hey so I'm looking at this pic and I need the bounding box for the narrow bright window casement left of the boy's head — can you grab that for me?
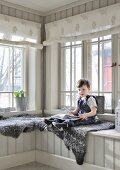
[60,41,82,107]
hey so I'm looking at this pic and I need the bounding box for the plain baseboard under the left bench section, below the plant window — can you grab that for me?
[0,150,35,170]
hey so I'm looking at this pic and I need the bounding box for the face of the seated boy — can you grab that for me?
[78,85,90,97]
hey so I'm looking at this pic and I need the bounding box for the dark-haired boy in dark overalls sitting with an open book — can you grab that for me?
[45,79,97,128]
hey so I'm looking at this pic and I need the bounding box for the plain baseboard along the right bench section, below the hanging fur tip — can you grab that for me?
[36,150,113,170]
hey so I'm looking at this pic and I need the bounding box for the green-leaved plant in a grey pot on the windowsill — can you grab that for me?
[13,90,27,111]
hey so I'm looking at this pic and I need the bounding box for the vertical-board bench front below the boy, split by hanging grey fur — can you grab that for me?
[36,131,120,170]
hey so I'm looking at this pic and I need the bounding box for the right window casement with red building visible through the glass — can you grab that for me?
[88,35,112,110]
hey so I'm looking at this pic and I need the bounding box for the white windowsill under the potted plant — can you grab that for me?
[0,110,42,117]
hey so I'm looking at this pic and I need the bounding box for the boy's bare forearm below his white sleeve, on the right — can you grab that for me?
[80,107,97,119]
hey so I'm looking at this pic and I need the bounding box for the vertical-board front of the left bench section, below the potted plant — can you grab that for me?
[0,131,35,157]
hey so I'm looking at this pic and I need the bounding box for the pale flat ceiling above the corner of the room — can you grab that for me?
[4,0,83,13]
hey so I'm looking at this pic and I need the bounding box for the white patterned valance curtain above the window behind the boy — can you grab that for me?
[43,4,120,45]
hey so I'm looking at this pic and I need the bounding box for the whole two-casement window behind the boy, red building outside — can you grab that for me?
[60,35,112,110]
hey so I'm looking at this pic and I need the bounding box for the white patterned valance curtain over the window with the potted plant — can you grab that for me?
[0,14,43,49]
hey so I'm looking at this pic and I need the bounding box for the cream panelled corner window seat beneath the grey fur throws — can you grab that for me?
[0,114,120,170]
